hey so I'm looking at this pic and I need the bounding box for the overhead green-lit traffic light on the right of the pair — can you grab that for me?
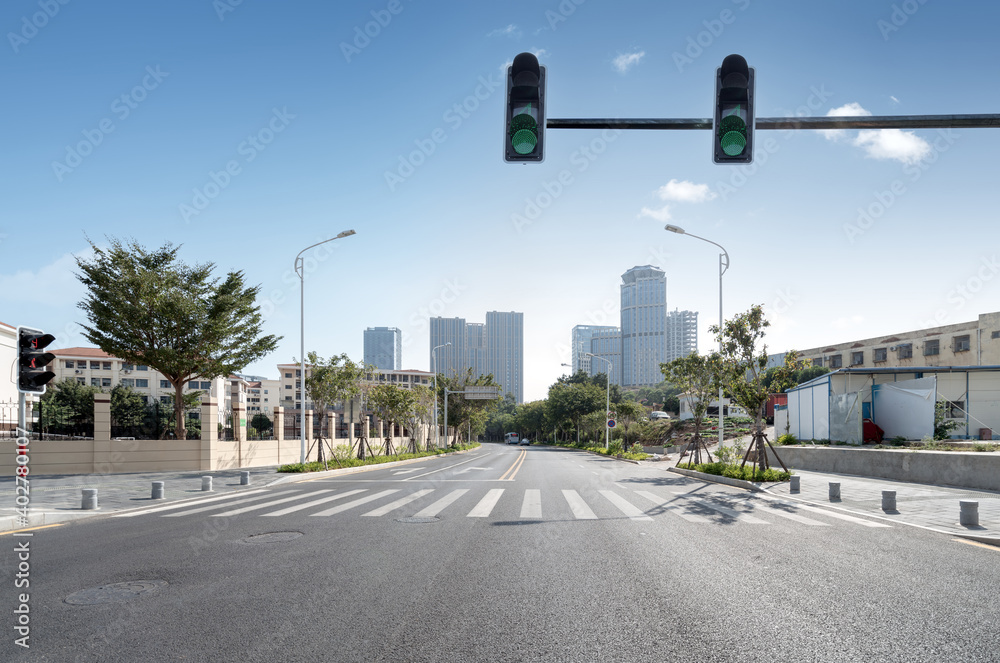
[712,54,754,163]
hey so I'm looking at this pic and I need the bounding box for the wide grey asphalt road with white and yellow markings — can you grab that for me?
[0,445,1000,663]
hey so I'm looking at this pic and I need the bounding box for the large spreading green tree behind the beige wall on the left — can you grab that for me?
[76,239,279,439]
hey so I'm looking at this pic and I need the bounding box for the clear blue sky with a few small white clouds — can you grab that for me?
[0,0,1000,400]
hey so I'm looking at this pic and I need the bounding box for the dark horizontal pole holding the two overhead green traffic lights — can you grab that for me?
[545,113,1000,131]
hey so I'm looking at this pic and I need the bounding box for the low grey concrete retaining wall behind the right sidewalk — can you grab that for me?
[768,446,1000,491]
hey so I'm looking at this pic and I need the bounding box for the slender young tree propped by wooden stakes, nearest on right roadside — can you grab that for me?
[709,304,802,471]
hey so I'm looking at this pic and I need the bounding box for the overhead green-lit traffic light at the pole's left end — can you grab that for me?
[503,53,545,163]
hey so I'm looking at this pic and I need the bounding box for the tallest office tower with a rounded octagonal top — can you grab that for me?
[621,265,667,387]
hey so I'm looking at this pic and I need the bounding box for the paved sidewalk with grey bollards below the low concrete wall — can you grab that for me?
[764,470,1000,545]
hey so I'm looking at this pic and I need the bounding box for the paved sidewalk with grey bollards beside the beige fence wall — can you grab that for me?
[0,466,286,532]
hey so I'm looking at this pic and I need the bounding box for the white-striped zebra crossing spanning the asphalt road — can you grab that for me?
[112,484,891,527]
